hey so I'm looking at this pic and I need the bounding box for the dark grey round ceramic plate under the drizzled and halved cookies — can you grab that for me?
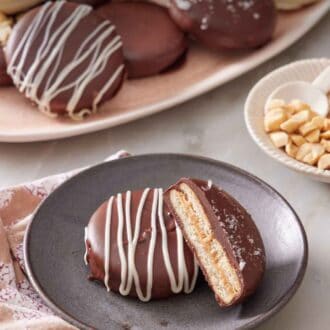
[25,154,307,329]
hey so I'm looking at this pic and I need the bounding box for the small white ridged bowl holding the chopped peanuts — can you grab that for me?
[244,58,330,183]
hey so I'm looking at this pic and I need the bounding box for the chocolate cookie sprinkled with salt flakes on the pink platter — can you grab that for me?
[169,0,276,50]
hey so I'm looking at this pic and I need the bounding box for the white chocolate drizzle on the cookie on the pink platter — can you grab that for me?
[7,1,124,119]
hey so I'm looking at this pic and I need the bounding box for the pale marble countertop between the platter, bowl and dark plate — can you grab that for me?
[0,13,330,330]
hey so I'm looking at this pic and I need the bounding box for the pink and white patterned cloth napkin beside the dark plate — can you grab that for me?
[0,151,129,330]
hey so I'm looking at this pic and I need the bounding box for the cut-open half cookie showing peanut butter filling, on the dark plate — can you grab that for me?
[164,178,265,307]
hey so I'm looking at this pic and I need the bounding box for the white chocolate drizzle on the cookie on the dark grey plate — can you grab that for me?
[85,188,198,302]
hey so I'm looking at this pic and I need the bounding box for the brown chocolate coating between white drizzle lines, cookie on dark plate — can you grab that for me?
[85,190,197,299]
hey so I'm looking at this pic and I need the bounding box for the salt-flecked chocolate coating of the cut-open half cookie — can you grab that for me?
[164,178,266,307]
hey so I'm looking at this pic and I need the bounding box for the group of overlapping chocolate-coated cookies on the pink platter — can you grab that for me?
[0,0,276,119]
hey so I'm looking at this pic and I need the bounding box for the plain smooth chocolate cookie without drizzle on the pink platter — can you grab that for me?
[97,2,187,78]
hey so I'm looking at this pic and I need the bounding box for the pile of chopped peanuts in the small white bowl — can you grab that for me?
[264,100,330,170]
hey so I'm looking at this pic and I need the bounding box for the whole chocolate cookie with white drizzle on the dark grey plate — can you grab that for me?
[85,189,198,302]
